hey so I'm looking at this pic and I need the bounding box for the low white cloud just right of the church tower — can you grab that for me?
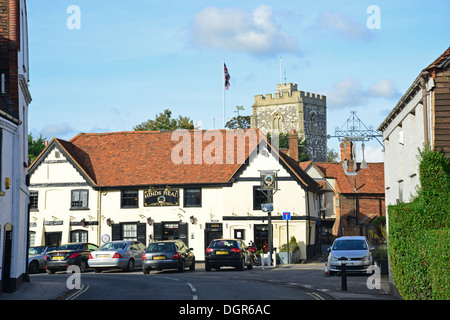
[326,77,399,107]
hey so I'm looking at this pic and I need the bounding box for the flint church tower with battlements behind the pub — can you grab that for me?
[251,83,327,162]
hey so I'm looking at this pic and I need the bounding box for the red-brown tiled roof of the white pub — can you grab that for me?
[30,129,317,189]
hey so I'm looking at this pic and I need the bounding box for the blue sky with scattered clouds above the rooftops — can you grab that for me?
[27,0,450,162]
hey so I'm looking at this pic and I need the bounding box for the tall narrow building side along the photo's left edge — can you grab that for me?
[0,0,31,293]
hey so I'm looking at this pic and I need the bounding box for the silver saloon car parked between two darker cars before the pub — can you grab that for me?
[88,241,145,272]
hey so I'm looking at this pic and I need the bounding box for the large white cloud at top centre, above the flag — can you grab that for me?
[192,5,298,55]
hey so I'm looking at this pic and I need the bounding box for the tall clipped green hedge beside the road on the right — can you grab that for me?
[388,147,450,300]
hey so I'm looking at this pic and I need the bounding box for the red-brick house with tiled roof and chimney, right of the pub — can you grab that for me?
[300,141,386,244]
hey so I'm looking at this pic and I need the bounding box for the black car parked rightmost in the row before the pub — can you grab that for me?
[205,239,253,271]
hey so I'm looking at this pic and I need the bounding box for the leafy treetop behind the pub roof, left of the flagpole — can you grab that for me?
[133,109,194,131]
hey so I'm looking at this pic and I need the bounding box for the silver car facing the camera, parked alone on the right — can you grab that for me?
[328,236,374,275]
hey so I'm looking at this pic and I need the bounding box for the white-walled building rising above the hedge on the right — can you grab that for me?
[378,48,450,205]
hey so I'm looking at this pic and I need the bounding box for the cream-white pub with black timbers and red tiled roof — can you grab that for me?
[29,129,322,261]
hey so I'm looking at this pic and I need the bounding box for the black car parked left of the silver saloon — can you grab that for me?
[44,242,98,274]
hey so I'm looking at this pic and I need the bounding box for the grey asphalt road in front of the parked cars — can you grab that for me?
[31,263,321,301]
